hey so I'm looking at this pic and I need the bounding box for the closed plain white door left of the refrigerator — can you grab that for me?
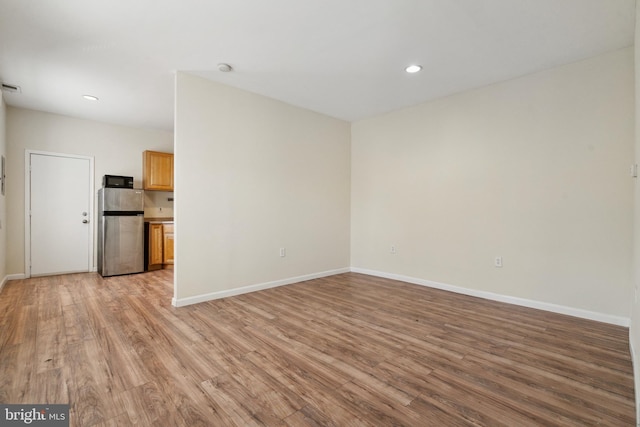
[27,152,93,276]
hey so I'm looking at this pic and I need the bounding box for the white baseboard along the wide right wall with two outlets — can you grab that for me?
[351,267,631,327]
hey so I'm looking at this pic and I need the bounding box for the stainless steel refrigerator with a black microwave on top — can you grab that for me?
[98,188,144,277]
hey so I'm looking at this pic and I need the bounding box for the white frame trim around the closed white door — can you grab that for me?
[24,149,96,279]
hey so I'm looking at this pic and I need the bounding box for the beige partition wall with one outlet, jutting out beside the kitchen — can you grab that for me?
[175,73,350,303]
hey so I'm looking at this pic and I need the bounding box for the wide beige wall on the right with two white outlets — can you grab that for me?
[351,48,634,318]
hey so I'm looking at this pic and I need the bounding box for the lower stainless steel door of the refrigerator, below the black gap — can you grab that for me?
[99,214,144,276]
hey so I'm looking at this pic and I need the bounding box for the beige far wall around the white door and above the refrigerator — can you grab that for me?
[7,107,173,275]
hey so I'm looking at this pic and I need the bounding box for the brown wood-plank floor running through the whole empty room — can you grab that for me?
[0,270,635,427]
